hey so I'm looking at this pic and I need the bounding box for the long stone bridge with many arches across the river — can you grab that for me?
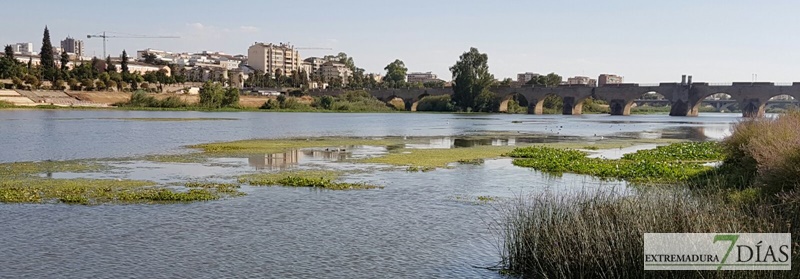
[310,81,800,117]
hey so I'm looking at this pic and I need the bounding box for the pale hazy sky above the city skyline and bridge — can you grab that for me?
[0,0,800,83]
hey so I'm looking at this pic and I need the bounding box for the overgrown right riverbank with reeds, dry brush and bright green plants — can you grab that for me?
[496,112,800,278]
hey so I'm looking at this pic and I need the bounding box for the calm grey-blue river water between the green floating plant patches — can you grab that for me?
[0,110,739,278]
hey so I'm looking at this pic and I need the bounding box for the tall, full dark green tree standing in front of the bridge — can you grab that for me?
[450,47,494,111]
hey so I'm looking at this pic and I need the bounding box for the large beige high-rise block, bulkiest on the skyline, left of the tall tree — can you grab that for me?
[247,43,301,75]
